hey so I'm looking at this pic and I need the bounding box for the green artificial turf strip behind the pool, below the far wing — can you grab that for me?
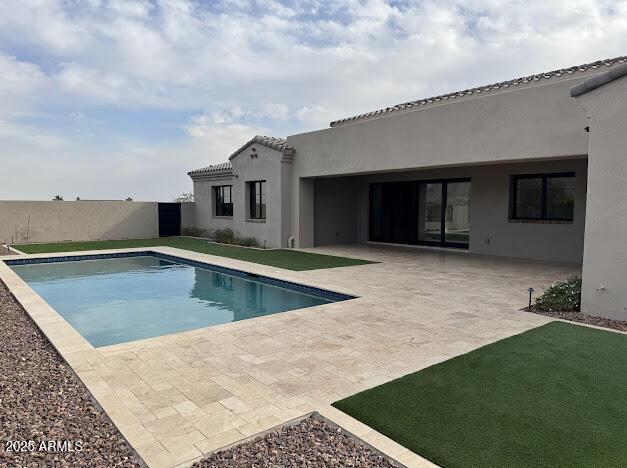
[14,236,374,271]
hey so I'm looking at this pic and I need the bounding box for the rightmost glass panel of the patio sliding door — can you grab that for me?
[444,181,470,245]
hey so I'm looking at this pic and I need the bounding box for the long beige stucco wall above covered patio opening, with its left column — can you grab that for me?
[287,72,598,245]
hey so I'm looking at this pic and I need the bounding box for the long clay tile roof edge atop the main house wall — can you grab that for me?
[331,56,627,127]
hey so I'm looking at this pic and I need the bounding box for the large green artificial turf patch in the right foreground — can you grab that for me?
[334,322,627,467]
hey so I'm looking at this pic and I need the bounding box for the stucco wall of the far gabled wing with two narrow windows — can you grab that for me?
[194,143,291,247]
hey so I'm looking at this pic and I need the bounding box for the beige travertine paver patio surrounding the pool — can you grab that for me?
[0,245,579,466]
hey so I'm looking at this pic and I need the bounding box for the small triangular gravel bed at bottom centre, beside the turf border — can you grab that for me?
[192,416,400,468]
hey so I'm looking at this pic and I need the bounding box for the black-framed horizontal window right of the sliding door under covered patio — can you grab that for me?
[510,172,575,221]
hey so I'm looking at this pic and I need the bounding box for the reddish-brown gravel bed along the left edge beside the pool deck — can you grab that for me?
[0,282,143,467]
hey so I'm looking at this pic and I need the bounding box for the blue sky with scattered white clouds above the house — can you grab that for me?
[0,0,627,201]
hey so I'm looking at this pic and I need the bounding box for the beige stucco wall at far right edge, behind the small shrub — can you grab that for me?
[577,77,627,320]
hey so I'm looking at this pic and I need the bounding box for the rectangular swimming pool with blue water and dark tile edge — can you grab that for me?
[5,252,353,347]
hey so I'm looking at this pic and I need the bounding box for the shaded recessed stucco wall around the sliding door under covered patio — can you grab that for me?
[315,158,587,263]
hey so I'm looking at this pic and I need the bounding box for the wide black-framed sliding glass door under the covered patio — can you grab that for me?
[370,179,470,248]
